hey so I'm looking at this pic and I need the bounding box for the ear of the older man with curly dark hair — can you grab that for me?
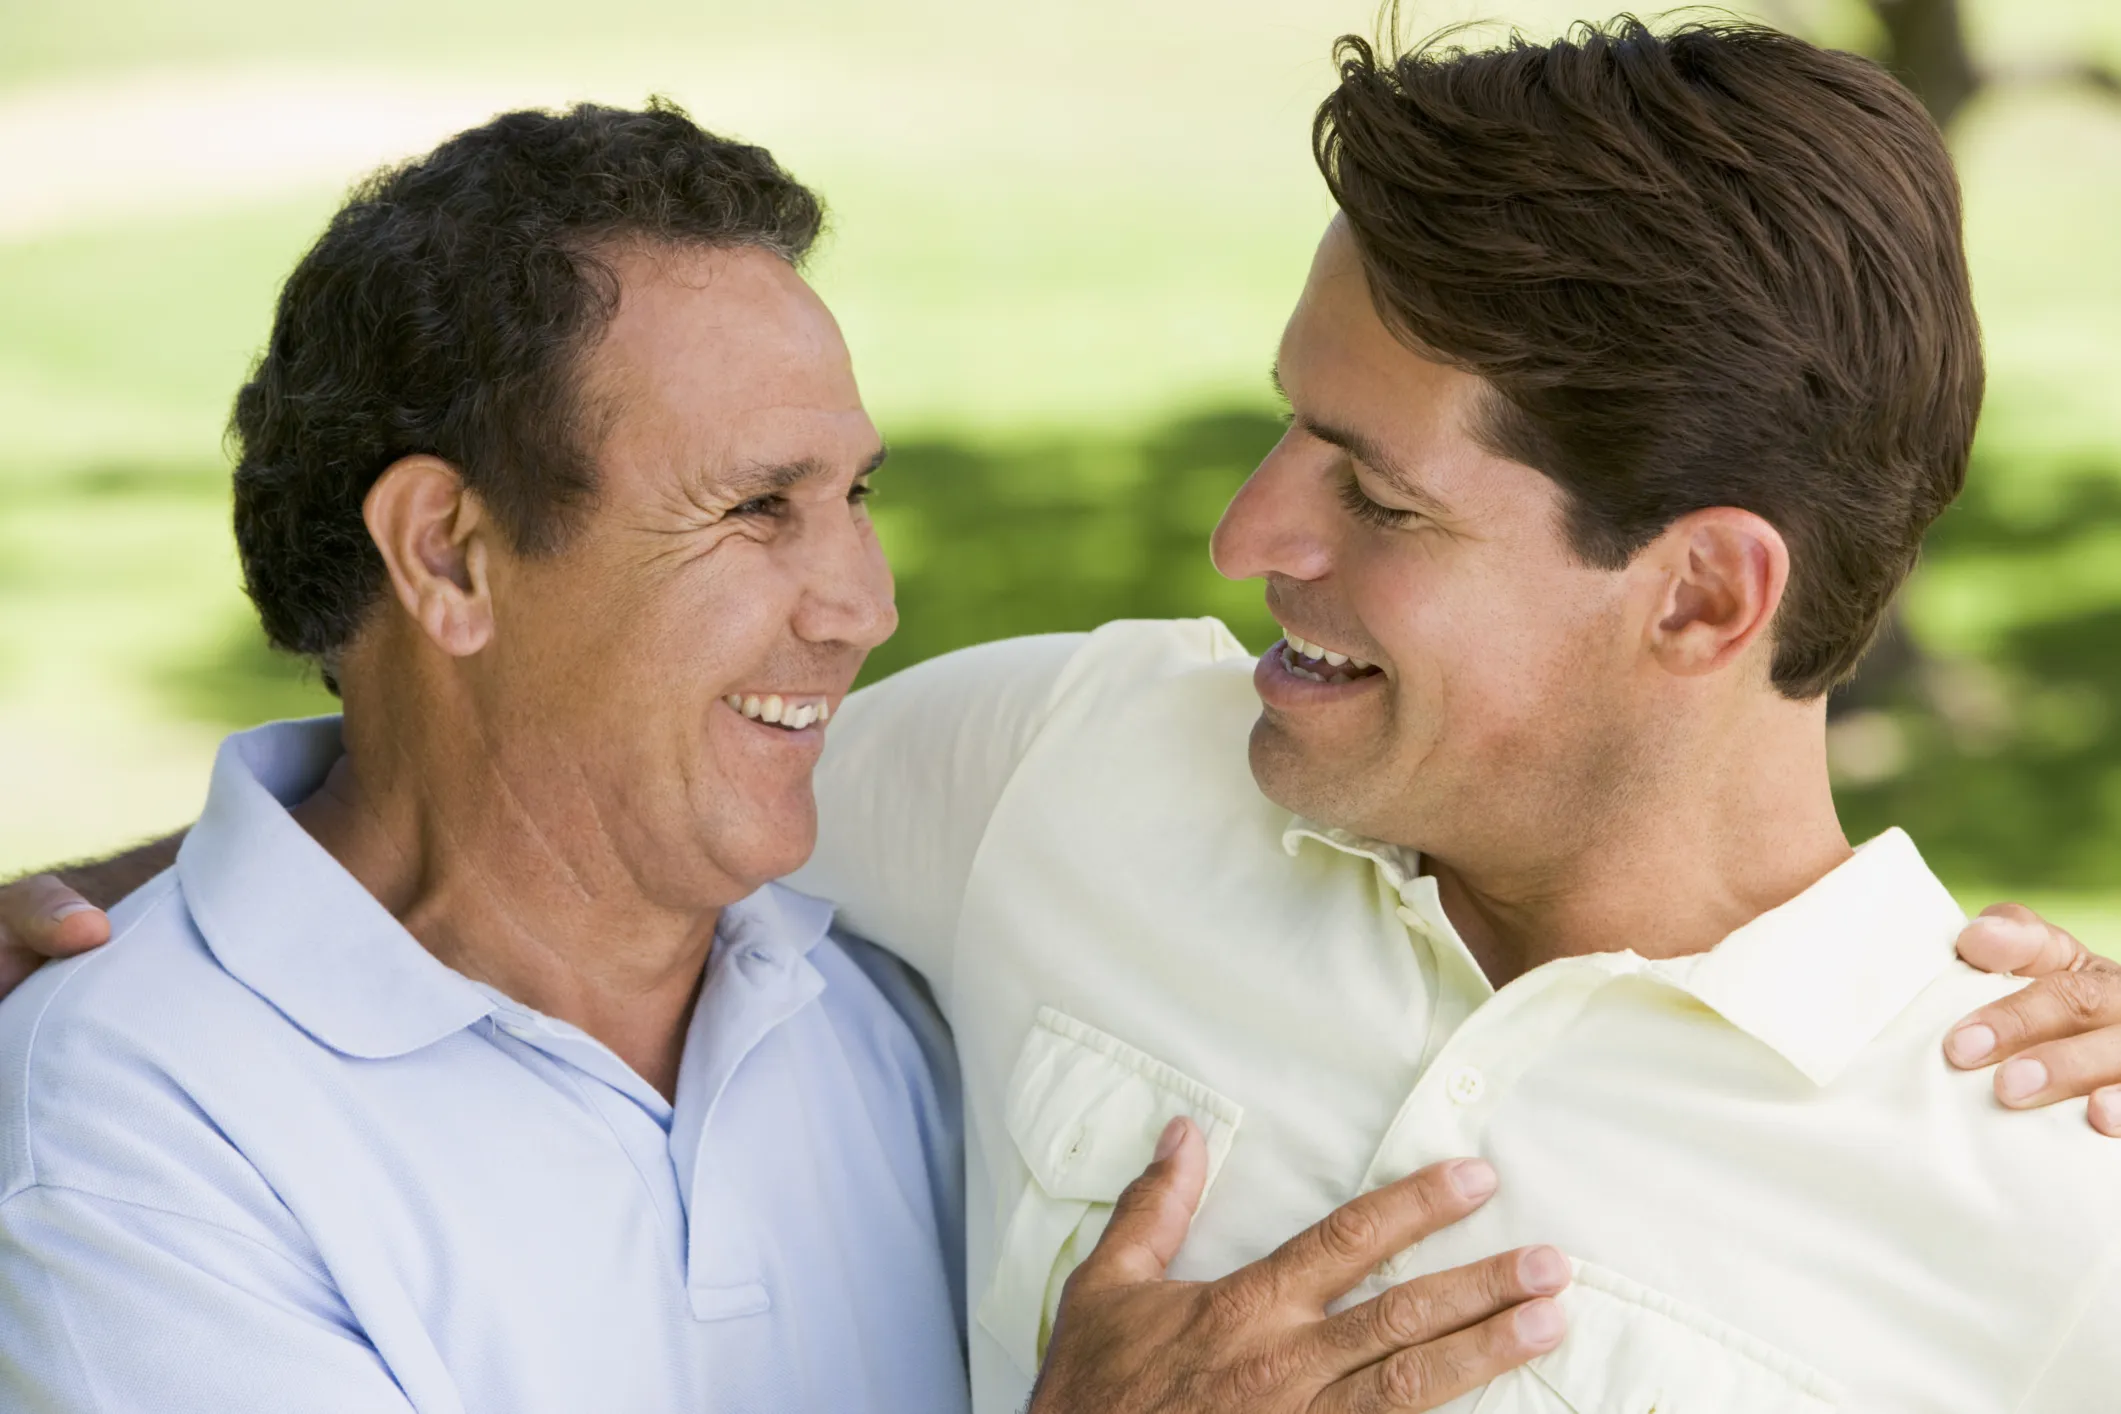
[361,454,494,657]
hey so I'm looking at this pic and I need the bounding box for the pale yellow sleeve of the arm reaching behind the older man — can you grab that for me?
[789,634,1088,1013]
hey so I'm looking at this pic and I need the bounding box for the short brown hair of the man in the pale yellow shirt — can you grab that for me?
[1313,15,1983,700]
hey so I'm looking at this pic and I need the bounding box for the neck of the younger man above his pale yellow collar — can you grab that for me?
[1427,697,1852,986]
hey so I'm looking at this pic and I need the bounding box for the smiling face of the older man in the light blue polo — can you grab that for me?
[484,250,897,907]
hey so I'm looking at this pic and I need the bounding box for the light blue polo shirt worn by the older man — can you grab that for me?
[0,721,967,1414]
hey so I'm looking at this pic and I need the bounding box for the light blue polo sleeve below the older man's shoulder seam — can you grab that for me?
[0,1187,414,1414]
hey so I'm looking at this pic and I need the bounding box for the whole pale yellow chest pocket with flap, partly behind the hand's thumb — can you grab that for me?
[978,1007,1245,1376]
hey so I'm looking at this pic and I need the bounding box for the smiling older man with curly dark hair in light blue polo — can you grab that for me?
[0,110,963,1414]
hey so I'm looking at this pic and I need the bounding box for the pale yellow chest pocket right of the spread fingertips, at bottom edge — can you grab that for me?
[1474,1261,1850,1414]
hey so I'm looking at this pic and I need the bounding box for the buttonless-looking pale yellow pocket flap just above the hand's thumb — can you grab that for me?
[1007,1007,1245,1202]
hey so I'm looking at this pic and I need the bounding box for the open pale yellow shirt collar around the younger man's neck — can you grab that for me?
[1281,816,1966,1085]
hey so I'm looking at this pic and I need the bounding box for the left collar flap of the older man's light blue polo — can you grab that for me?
[176,717,494,1060]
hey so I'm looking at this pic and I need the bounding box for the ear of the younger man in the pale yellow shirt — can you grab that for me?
[1642,507,1790,676]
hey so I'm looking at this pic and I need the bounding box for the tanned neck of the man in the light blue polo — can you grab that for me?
[293,648,719,1098]
